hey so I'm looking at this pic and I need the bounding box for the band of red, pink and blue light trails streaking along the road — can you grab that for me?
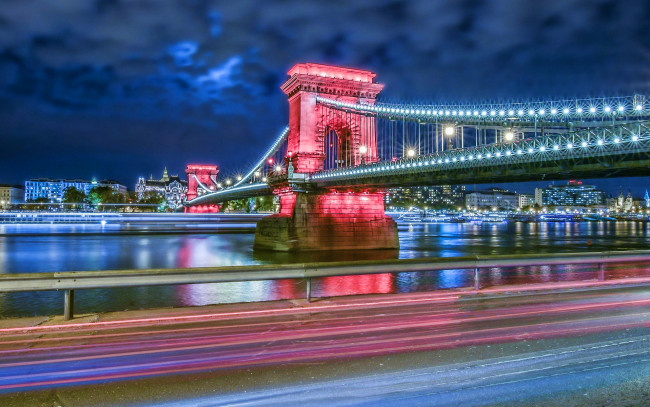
[0,286,650,393]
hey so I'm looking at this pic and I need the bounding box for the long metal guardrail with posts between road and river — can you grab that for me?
[0,250,650,320]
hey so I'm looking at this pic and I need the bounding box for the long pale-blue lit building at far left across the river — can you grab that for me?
[25,178,126,203]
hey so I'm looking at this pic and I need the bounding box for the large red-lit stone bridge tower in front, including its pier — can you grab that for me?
[254,64,399,251]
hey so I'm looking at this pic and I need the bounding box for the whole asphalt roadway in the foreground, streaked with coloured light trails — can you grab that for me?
[0,283,650,406]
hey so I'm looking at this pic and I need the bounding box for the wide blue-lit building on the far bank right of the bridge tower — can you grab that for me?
[535,180,605,207]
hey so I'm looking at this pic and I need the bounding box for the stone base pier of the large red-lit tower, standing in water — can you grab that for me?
[253,188,399,251]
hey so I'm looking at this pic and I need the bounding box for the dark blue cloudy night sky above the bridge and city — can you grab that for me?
[0,0,650,195]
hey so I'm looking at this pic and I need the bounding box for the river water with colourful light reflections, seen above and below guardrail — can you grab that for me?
[0,219,650,318]
